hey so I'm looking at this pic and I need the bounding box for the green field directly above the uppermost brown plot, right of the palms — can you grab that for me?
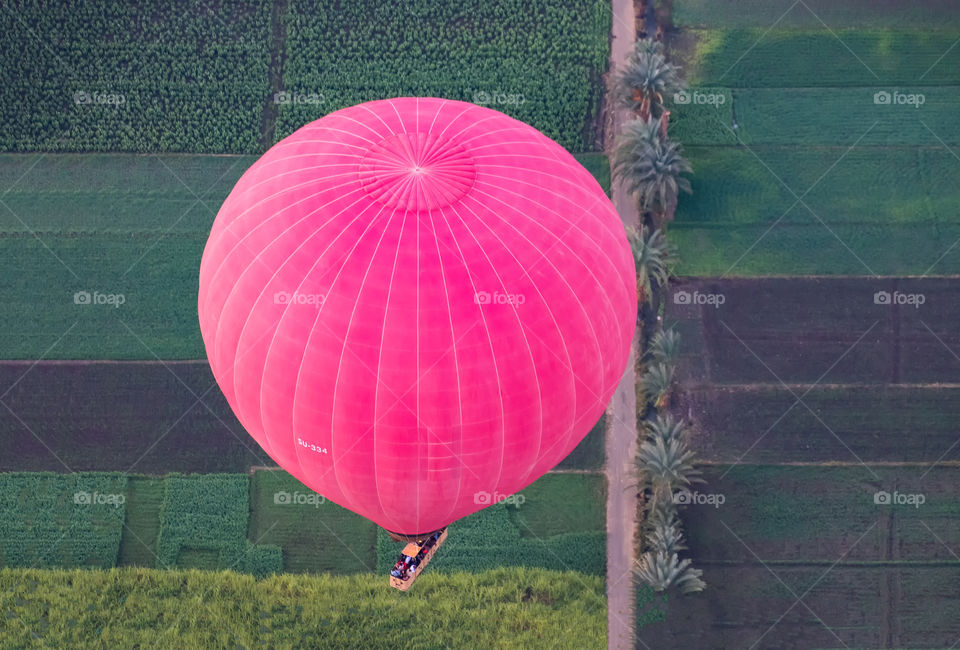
[671,146,960,276]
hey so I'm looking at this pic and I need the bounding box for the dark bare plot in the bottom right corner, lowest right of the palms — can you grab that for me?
[638,560,960,648]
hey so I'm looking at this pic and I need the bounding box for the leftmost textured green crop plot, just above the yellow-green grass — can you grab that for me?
[0,473,127,567]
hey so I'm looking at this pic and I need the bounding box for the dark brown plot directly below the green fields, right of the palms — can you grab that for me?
[666,277,960,384]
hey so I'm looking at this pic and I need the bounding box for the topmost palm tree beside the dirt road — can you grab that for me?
[615,38,683,121]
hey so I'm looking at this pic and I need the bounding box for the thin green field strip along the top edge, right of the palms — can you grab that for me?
[673,0,960,29]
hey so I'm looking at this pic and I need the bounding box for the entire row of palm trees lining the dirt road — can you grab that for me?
[613,39,706,593]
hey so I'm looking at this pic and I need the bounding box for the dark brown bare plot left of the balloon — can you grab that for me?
[0,362,272,474]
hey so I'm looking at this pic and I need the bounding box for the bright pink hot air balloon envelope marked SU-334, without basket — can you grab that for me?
[199,97,637,536]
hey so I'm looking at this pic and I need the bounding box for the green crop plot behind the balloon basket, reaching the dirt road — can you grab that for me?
[377,474,606,575]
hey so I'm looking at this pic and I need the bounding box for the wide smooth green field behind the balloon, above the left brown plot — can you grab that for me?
[0,154,610,360]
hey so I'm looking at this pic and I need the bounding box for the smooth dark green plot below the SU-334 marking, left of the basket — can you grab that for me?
[247,470,377,574]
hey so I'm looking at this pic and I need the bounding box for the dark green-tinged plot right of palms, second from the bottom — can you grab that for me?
[682,466,960,566]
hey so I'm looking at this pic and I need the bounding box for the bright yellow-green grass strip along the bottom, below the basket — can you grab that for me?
[0,568,606,650]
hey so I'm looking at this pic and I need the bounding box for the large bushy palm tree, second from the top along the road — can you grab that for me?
[613,135,693,225]
